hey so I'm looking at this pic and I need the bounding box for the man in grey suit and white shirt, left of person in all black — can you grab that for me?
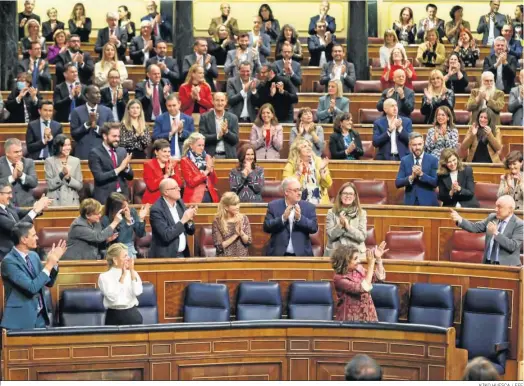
[227,62,258,123]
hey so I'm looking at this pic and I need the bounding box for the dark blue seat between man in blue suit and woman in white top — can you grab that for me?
[59,288,106,327]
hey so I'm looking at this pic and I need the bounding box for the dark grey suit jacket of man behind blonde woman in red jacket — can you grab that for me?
[198,110,238,158]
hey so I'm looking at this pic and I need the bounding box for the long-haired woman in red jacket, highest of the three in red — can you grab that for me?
[178,64,213,115]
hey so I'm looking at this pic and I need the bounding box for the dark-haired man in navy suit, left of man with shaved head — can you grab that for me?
[25,100,62,160]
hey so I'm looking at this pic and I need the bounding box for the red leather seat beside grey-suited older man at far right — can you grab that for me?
[449,229,486,264]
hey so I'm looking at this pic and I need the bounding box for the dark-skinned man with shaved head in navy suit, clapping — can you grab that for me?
[71,85,114,160]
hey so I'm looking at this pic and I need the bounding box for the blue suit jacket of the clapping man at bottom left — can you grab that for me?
[1,248,58,330]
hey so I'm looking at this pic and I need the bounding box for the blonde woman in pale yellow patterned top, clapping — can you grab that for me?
[283,137,333,204]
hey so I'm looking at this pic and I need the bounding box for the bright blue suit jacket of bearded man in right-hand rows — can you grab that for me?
[395,153,439,206]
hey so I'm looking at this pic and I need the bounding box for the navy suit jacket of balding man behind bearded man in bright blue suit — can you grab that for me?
[373,116,413,161]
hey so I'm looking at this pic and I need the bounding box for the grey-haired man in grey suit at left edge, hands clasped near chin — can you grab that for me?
[0,138,38,207]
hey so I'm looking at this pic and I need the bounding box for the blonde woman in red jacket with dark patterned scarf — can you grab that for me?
[180,133,219,204]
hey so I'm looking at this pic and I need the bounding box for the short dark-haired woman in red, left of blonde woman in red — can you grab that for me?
[142,139,183,204]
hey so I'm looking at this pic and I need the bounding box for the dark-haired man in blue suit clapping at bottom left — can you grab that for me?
[0,222,65,330]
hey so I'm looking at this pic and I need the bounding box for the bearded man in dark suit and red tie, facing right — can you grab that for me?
[88,122,133,203]
